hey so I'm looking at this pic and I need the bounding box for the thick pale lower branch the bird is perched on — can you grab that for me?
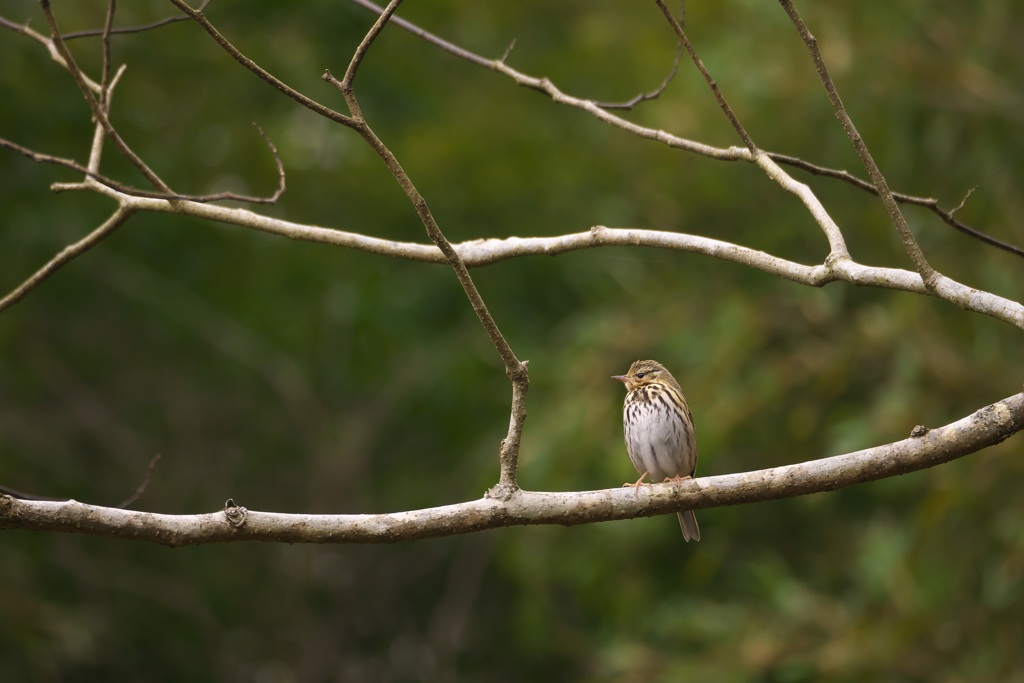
[0,394,1024,547]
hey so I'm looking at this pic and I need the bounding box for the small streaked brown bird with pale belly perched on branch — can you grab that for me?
[611,360,700,541]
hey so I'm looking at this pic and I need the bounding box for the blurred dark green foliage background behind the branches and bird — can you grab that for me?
[0,0,1024,683]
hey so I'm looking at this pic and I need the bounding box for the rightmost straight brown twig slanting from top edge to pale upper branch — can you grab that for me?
[774,0,941,288]
